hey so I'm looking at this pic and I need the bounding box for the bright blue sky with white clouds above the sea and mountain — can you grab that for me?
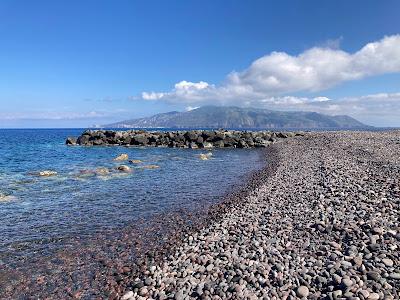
[0,0,400,128]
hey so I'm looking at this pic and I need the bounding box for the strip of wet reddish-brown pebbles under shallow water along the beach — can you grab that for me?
[0,148,276,299]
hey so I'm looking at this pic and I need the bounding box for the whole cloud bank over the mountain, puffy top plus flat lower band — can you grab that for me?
[141,35,400,125]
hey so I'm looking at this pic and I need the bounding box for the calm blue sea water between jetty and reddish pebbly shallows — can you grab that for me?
[0,129,262,265]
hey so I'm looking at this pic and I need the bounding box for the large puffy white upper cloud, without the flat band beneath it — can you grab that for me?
[141,35,400,105]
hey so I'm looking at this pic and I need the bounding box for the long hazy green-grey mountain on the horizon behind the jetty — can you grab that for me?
[103,106,369,129]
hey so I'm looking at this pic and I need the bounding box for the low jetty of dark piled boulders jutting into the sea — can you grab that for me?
[66,129,304,149]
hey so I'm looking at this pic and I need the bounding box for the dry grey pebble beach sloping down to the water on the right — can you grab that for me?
[121,131,400,300]
